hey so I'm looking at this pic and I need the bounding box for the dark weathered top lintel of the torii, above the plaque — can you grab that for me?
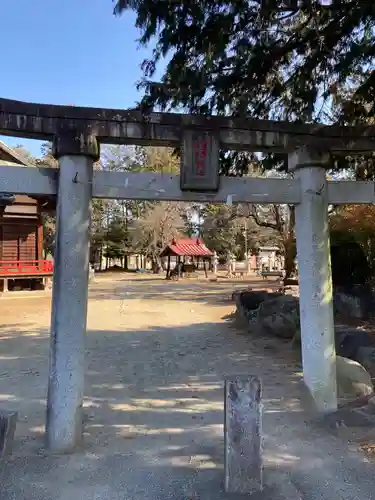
[0,98,375,153]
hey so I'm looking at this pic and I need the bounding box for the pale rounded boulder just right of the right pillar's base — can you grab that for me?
[336,356,374,399]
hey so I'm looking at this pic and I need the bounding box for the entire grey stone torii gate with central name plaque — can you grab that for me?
[0,99,375,452]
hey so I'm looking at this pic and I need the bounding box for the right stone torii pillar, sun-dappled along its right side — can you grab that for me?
[288,149,337,413]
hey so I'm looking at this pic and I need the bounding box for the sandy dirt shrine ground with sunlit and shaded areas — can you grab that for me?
[0,275,375,500]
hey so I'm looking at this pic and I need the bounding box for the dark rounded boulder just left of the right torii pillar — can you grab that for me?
[256,295,300,340]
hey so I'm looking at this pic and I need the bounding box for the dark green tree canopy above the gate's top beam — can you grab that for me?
[115,0,375,177]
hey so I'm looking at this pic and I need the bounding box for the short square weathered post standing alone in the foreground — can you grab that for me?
[224,376,263,493]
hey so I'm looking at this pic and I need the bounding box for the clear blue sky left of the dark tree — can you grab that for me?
[0,0,163,156]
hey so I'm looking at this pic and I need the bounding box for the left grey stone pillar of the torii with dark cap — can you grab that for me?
[46,132,99,453]
